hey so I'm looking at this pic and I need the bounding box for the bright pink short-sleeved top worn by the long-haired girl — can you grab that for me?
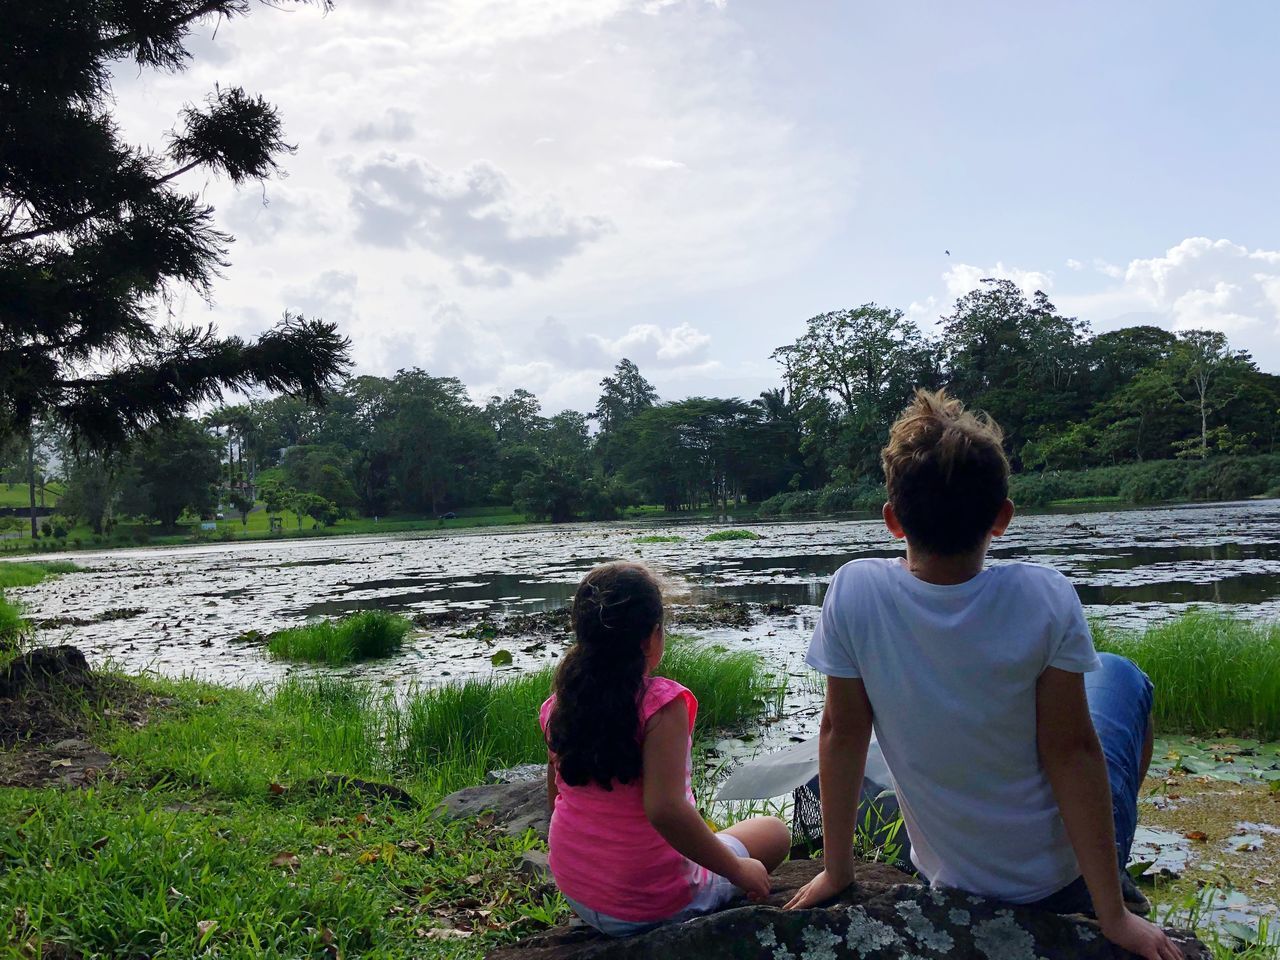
[538,677,707,923]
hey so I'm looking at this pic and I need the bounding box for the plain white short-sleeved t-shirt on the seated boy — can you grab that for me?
[805,558,1101,904]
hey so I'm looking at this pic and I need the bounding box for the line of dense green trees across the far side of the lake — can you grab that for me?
[15,280,1280,529]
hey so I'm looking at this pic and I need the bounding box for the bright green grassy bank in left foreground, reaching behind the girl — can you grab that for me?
[0,643,771,957]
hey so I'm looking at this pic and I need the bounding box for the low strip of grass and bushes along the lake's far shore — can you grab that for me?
[0,454,1280,557]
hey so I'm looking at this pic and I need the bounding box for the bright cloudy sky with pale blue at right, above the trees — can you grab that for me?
[114,0,1280,413]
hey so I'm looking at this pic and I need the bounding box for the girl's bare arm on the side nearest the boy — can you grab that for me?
[644,699,771,900]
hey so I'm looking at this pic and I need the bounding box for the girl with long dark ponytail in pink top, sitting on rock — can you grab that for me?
[539,563,790,937]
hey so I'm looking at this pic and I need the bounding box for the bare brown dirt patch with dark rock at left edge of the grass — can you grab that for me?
[0,646,168,787]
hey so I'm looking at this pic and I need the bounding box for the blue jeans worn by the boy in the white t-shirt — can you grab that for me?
[1028,653,1153,914]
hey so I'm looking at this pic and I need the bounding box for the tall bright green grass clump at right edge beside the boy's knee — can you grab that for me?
[1093,611,1280,740]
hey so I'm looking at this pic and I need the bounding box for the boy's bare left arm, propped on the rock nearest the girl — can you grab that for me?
[787,677,872,910]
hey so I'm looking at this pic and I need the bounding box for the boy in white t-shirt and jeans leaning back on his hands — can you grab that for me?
[788,390,1181,960]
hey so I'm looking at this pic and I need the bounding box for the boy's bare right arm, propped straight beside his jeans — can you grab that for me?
[1036,667,1181,960]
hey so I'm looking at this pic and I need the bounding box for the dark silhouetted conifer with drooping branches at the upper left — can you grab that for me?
[0,0,348,537]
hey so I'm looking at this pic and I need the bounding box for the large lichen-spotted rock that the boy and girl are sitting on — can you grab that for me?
[488,860,1212,960]
